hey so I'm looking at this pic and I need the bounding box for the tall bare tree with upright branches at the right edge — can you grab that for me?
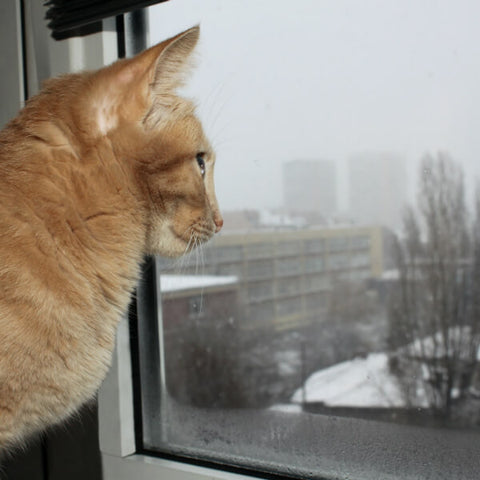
[389,154,480,419]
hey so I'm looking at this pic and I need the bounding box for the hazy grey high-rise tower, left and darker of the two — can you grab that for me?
[283,160,337,219]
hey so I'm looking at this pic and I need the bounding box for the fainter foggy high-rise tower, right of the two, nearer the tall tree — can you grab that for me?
[348,152,407,229]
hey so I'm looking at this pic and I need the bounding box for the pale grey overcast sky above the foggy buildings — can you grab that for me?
[150,0,480,210]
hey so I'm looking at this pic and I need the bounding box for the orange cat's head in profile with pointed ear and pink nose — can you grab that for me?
[83,27,223,256]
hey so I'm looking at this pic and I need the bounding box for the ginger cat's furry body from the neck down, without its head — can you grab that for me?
[0,78,142,449]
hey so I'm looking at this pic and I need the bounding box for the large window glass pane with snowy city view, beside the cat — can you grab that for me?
[142,0,480,479]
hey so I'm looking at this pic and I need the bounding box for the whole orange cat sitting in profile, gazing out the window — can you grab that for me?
[0,27,223,450]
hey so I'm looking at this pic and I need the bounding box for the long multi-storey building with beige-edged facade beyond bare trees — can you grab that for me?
[158,227,391,330]
